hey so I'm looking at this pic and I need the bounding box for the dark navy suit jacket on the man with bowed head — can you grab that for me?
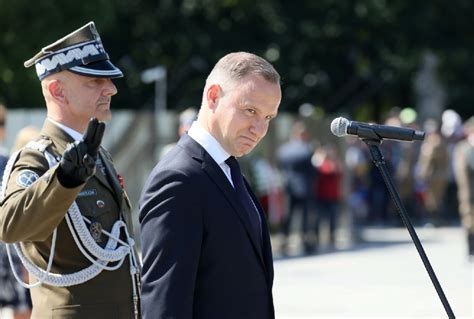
[140,134,274,319]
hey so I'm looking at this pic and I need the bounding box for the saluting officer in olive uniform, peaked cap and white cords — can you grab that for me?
[0,22,139,319]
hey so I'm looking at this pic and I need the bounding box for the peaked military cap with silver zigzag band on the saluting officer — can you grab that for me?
[24,22,123,80]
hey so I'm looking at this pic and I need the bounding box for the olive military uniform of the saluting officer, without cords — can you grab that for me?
[0,120,134,319]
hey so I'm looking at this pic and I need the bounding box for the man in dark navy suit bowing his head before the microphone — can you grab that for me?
[140,52,281,319]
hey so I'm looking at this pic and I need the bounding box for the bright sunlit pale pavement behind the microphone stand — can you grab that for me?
[273,227,474,319]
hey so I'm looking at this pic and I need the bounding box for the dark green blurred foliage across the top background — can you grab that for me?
[0,0,474,120]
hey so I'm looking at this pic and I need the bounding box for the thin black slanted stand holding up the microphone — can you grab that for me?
[362,138,456,319]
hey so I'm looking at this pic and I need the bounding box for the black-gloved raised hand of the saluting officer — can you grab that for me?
[58,118,105,188]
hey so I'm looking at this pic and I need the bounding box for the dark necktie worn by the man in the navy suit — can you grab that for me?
[225,156,262,244]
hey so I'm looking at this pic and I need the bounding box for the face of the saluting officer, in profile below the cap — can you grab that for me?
[65,72,117,127]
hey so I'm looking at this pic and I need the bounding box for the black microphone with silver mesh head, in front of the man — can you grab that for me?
[331,117,425,141]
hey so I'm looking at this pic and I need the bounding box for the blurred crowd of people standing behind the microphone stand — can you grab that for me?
[246,108,474,255]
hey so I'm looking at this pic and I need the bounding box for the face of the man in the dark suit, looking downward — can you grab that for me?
[210,76,281,157]
